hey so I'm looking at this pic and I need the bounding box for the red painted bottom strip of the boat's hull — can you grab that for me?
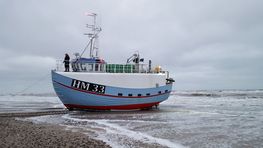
[64,102,160,110]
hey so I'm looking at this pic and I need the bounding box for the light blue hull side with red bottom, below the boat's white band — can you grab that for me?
[51,71,172,110]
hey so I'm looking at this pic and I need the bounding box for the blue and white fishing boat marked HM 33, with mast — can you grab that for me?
[51,13,174,110]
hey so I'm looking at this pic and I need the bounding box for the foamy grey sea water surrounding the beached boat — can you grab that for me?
[0,90,263,148]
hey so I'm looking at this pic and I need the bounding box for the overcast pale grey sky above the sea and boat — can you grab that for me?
[0,0,263,94]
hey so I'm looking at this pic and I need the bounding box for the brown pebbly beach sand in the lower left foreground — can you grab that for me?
[0,111,110,148]
